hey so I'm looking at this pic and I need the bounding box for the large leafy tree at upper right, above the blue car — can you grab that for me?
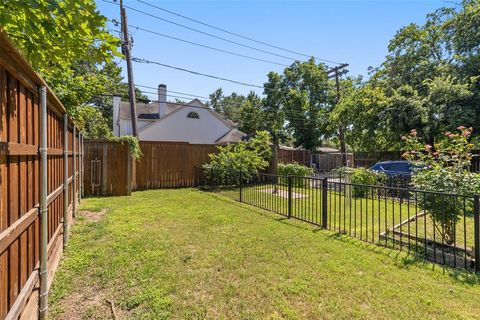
[332,0,480,151]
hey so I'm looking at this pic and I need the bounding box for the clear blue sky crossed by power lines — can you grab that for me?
[97,0,451,101]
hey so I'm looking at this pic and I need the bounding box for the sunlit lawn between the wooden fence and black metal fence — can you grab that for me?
[50,189,480,319]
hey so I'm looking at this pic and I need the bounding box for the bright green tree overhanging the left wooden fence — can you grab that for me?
[0,0,120,118]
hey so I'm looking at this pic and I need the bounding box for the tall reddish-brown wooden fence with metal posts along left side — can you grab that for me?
[0,29,82,319]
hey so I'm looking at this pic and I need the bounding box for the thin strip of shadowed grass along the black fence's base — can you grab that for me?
[202,190,480,286]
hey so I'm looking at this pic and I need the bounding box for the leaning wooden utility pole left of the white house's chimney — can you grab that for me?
[120,0,137,137]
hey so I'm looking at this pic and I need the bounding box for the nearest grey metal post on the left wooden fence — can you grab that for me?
[38,86,48,319]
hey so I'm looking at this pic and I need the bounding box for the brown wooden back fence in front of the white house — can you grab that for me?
[84,140,217,196]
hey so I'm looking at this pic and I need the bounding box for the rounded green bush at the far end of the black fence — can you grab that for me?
[203,131,272,179]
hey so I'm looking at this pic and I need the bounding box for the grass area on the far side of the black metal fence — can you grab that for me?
[216,184,474,250]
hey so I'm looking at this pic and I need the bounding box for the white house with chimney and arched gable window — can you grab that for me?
[113,84,246,144]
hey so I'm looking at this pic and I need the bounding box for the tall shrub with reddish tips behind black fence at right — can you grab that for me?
[403,126,480,243]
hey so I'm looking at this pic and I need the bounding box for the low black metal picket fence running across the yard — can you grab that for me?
[204,171,480,272]
